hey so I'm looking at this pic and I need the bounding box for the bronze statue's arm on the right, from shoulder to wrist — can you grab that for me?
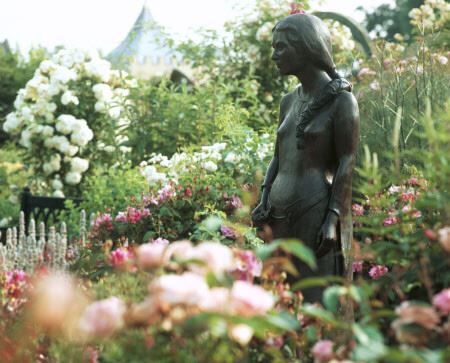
[329,92,359,216]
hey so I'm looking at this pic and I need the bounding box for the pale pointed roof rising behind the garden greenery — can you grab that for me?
[107,2,179,68]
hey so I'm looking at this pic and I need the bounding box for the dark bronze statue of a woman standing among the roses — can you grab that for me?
[252,14,359,302]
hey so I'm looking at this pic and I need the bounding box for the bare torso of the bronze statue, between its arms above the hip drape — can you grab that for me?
[270,92,337,207]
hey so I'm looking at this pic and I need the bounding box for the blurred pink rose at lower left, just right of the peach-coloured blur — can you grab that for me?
[80,297,126,338]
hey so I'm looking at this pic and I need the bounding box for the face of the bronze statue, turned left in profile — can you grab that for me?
[272,30,304,75]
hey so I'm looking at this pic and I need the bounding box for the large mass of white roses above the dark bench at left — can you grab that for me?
[3,49,135,196]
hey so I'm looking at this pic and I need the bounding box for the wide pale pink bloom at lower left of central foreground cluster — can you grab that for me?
[149,272,209,306]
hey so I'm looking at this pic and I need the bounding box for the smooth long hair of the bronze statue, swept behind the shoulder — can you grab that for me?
[273,14,340,79]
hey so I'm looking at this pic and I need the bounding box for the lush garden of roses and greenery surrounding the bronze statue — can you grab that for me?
[0,0,450,363]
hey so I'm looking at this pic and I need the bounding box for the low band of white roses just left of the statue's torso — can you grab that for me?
[140,132,273,186]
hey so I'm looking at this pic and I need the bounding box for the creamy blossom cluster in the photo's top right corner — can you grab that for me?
[409,0,450,31]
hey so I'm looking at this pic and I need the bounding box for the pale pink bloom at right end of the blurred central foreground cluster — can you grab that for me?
[231,281,275,317]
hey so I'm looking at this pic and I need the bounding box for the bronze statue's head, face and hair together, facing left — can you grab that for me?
[272,14,335,78]
